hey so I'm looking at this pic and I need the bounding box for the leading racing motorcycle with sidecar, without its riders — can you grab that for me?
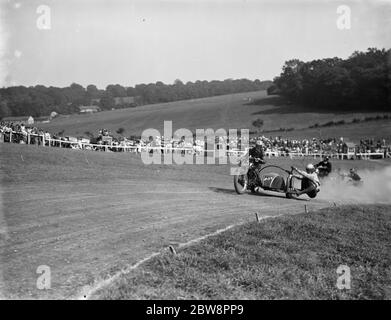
[234,158,316,199]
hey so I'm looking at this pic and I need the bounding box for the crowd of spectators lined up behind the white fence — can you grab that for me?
[0,121,391,157]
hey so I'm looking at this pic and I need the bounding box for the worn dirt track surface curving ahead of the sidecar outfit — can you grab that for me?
[0,145,330,299]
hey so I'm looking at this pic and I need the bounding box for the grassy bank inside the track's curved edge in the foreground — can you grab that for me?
[94,205,391,299]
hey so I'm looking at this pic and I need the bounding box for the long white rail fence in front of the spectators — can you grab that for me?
[0,131,391,160]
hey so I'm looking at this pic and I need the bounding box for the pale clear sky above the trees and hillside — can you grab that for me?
[0,0,391,89]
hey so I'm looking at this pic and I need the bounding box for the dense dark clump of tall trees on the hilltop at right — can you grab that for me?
[268,48,391,112]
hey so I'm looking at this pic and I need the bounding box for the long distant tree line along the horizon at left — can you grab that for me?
[0,79,272,118]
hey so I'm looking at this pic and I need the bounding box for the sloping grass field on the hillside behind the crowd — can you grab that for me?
[39,91,391,141]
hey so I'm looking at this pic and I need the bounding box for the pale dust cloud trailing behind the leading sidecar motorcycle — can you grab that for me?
[318,166,391,204]
